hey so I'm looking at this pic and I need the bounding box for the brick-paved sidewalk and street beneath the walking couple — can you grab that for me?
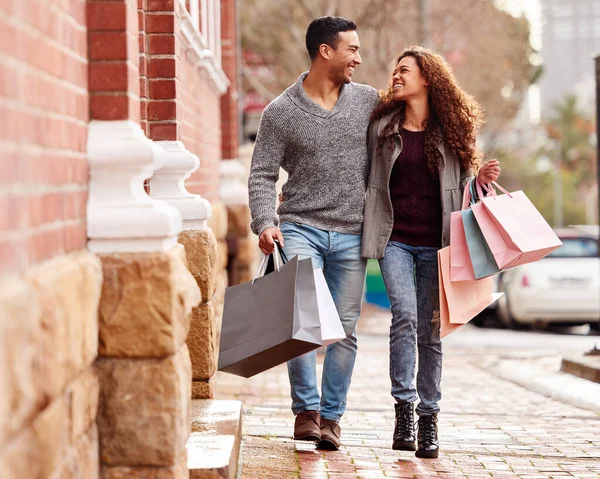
[217,310,600,479]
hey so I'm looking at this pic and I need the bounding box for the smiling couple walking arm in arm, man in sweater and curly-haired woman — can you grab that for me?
[249,17,500,457]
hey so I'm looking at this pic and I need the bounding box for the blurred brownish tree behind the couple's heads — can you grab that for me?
[242,0,534,134]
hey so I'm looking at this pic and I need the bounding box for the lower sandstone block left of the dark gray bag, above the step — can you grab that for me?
[187,301,218,379]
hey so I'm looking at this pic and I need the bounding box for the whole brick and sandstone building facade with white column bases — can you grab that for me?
[0,0,253,479]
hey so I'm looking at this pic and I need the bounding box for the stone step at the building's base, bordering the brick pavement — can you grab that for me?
[186,399,242,479]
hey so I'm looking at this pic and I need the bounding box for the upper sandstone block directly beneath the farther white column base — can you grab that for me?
[179,229,219,303]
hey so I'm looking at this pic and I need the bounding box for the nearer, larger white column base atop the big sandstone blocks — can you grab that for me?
[87,120,182,254]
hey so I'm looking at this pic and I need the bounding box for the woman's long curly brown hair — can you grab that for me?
[371,46,483,173]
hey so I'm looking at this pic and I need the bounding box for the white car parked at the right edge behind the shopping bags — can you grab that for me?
[497,228,600,329]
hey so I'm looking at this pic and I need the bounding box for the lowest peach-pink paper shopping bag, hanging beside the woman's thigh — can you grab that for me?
[438,247,504,338]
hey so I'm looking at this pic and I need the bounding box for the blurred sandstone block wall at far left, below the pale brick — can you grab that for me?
[0,252,102,479]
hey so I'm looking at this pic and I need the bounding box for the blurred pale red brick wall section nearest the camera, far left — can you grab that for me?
[0,0,89,273]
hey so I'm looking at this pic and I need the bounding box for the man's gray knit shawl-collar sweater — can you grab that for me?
[248,73,378,234]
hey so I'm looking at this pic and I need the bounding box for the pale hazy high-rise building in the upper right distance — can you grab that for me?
[540,0,600,116]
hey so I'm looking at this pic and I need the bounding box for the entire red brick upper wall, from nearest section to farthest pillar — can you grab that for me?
[0,0,237,273]
